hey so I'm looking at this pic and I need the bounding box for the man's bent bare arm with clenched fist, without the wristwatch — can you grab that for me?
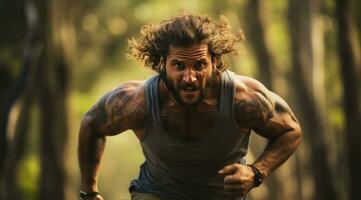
[220,77,302,195]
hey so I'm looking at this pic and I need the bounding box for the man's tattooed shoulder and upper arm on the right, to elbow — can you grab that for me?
[234,76,301,139]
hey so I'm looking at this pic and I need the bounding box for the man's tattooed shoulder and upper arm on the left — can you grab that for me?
[87,81,146,135]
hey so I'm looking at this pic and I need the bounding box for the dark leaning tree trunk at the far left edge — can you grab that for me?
[0,1,42,199]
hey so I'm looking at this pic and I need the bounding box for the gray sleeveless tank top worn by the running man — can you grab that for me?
[130,71,250,200]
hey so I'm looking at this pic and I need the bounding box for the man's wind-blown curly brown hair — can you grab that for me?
[128,13,244,73]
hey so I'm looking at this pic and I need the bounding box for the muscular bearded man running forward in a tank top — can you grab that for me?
[78,14,301,200]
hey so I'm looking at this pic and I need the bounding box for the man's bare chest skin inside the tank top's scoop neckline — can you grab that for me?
[160,107,218,142]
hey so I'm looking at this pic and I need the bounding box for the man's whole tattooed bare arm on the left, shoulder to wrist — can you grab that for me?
[78,83,146,198]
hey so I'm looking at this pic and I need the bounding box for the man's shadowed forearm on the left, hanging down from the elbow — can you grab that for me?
[78,117,105,192]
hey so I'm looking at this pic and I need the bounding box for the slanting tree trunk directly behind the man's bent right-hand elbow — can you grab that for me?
[289,0,337,200]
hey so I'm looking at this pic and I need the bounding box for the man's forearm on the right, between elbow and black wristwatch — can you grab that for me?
[254,129,301,176]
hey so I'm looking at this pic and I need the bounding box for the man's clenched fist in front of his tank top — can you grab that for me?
[218,163,254,196]
